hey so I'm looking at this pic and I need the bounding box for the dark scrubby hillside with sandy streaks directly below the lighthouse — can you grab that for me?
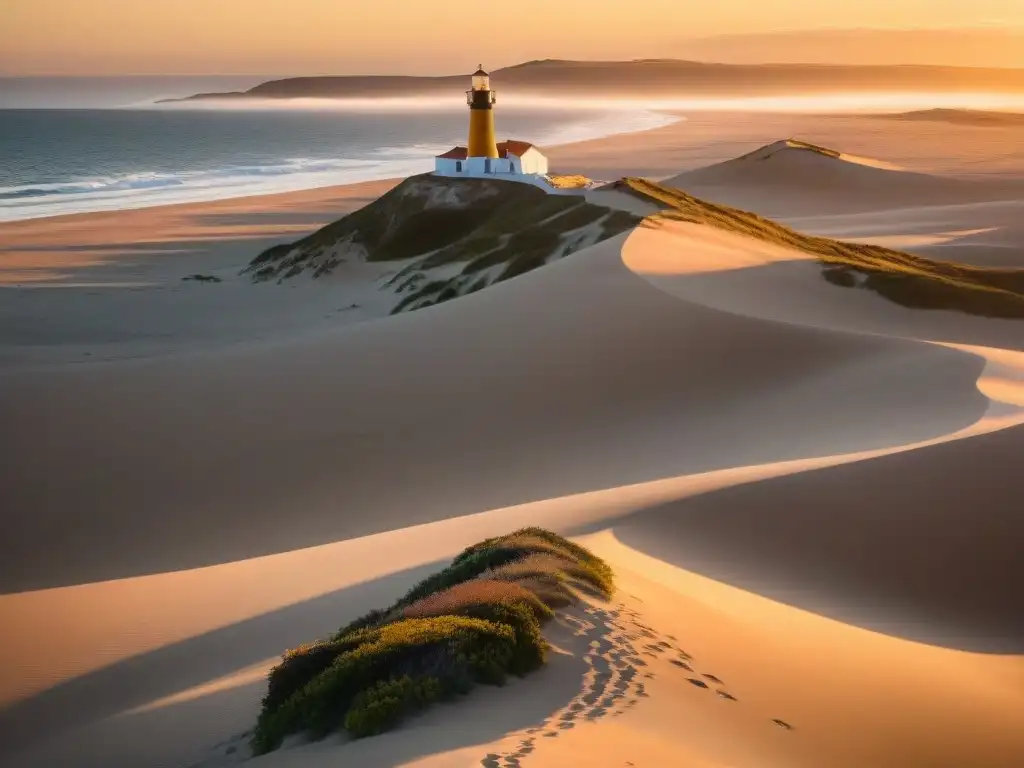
[246,175,639,312]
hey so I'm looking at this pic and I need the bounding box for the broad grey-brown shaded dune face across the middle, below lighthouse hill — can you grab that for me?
[0,241,987,593]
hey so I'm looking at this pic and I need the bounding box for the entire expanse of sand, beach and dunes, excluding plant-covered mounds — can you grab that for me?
[0,113,1024,768]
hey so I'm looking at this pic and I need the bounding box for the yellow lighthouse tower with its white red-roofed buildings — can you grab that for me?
[434,66,548,180]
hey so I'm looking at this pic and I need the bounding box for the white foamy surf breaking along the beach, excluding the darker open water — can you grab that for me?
[0,111,679,221]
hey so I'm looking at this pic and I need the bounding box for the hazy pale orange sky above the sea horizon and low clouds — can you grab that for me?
[0,0,1024,75]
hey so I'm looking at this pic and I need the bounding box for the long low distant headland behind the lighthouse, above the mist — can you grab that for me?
[163,58,1024,102]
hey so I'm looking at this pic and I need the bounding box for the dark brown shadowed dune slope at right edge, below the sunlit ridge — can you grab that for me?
[614,427,1024,653]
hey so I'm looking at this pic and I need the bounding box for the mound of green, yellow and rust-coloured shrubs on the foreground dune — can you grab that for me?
[252,527,613,755]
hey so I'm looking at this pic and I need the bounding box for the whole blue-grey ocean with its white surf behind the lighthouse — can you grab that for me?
[0,105,677,221]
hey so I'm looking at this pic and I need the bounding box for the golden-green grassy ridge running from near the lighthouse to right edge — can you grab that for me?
[616,177,1024,318]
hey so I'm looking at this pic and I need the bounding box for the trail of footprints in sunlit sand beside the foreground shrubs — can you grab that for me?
[480,603,793,768]
